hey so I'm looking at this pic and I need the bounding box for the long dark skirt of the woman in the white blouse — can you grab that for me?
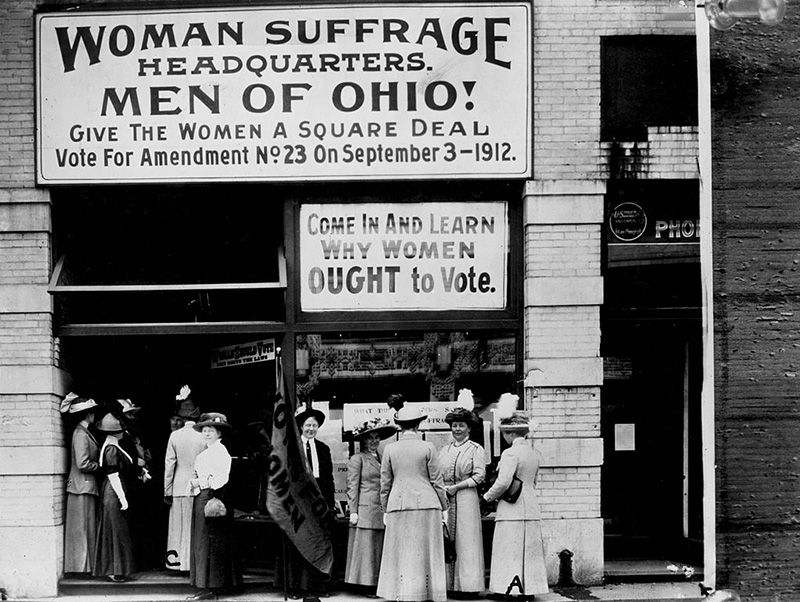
[189,489,242,589]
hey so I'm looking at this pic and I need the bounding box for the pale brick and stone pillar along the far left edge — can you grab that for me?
[0,1,66,597]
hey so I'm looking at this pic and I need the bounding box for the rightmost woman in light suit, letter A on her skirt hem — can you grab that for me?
[483,412,549,598]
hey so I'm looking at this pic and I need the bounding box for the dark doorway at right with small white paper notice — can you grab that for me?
[601,321,702,563]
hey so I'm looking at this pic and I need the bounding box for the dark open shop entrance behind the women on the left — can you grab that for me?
[62,334,280,583]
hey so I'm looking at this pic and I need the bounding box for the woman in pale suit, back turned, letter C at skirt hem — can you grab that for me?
[164,385,206,571]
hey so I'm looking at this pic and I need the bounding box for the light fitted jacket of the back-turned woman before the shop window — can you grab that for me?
[381,432,447,512]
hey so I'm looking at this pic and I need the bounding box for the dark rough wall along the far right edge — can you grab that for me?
[711,11,800,601]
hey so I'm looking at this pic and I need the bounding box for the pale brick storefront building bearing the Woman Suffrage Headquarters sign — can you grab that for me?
[0,0,713,597]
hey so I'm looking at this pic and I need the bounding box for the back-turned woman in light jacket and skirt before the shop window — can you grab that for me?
[376,395,447,602]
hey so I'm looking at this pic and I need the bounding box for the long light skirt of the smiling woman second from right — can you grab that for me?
[447,488,486,592]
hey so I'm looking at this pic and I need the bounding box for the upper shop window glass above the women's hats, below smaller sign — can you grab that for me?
[296,332,516,410]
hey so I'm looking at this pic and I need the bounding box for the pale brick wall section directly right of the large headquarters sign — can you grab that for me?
[533,0,694,180]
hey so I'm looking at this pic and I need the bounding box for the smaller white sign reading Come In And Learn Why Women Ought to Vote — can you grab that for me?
[300,202,508,311]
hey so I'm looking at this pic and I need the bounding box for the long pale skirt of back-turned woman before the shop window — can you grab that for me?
[377,509,447,602]
